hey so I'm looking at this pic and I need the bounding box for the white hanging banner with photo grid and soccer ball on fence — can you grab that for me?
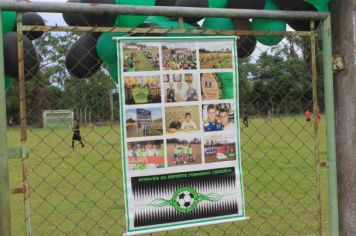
[116,36,246,235]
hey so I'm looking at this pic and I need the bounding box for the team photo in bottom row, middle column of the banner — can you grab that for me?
[167,137,202,166]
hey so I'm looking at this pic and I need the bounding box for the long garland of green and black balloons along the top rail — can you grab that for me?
[63,0,329,82]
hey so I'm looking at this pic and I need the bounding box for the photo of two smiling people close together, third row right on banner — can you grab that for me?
[202,103,236,132]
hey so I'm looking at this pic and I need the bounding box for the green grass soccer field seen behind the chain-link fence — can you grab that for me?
[8,116,328,235]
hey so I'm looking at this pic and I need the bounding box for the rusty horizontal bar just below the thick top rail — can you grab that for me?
[22,25,311,36]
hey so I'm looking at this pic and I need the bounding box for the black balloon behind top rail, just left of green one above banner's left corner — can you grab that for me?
[80,0,116,27]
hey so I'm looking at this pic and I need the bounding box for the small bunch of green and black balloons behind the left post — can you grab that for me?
[2,11,45,90]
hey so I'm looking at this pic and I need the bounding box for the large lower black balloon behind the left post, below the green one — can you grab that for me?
[4,32,40,79]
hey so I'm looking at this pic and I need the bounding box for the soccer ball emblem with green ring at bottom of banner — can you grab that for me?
[172,187,199,212]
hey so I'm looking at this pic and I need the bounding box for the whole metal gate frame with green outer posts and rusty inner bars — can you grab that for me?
[0,1,339,236]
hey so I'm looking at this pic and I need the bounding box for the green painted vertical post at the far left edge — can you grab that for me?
[0,11,11,236]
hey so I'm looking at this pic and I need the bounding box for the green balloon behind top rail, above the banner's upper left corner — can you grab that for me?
[115,0,156,27]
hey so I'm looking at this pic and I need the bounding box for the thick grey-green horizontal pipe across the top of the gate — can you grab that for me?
[0,0,328,20]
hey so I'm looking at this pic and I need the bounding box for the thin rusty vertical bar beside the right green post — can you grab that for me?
[310,21,323,236]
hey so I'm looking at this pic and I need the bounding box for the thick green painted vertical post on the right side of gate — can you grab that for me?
[322,16,339,236]
